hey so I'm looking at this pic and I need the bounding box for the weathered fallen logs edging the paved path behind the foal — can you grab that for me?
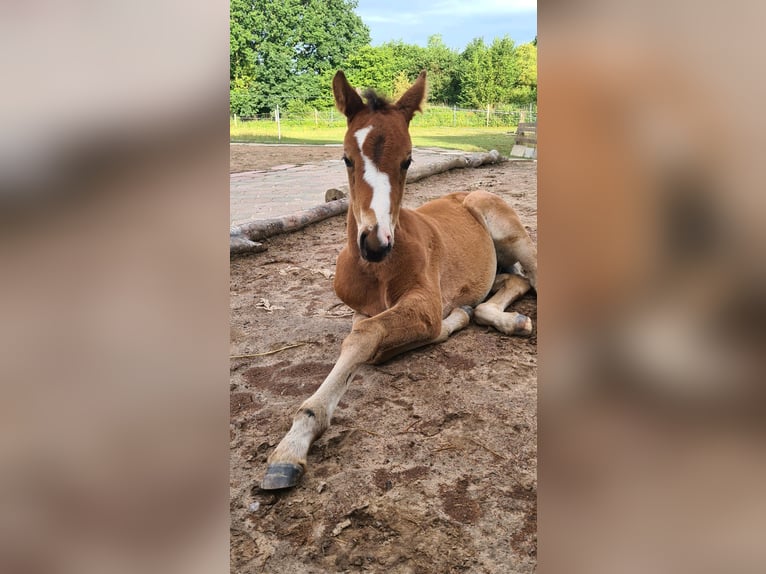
[234,150,503,254]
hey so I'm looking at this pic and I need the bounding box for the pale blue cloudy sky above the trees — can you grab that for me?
[356,0,537,52]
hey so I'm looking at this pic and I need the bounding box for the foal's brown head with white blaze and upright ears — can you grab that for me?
[332,72,426,262]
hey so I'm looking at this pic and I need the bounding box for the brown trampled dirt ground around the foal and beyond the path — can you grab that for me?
[230,146,537,574]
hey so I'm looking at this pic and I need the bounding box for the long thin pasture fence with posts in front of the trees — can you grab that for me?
[231,104,537,132]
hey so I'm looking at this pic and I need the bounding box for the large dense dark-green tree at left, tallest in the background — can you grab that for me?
[229,0,370,113]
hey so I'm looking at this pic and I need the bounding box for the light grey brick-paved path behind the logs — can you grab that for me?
[229,149,465,227]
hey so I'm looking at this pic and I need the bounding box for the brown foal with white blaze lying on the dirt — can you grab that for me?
[261,72,537,490]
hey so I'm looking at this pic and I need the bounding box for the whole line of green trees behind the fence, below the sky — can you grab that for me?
[230,0,537,116]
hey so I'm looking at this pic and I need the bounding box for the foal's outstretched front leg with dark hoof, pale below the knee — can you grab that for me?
[261,297,460,490]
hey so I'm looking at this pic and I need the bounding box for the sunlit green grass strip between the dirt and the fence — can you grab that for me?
[229,121,513,155]
